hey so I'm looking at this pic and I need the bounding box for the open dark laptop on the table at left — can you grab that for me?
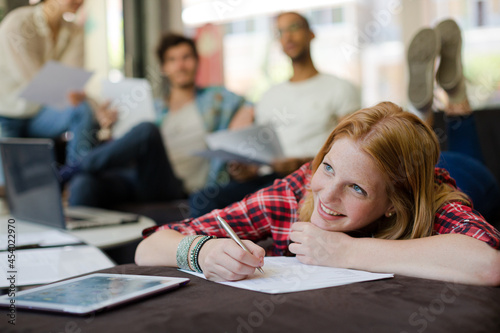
[0,138,139,230]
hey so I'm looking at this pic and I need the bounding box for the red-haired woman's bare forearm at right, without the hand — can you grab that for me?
[345,234,500,286]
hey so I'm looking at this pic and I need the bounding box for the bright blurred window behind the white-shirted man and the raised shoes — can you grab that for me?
[183,0,500,108]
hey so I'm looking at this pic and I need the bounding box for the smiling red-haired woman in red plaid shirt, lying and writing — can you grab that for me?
[136,102,500,286]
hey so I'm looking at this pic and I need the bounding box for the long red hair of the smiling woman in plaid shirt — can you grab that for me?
[299,102,470,239]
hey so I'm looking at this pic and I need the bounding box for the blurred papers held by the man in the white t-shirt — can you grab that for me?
[195,125,284,165]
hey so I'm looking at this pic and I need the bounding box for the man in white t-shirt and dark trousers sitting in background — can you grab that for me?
[190,12,361,216]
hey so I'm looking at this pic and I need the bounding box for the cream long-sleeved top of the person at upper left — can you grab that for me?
[0,5,84,118]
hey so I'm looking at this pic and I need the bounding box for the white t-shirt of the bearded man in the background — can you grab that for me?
[255,74,360,157]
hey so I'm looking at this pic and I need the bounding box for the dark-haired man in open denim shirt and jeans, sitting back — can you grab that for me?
[69,34,252,207]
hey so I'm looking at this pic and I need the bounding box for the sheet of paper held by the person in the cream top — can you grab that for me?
[19,60,93,109]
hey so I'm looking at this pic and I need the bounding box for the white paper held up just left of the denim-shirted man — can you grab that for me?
[101,78,156,139]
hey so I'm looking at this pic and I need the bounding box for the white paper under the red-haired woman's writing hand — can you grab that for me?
[181,257,394,294]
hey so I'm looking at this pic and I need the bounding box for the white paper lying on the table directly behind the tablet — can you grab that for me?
[0,245,115,288]
